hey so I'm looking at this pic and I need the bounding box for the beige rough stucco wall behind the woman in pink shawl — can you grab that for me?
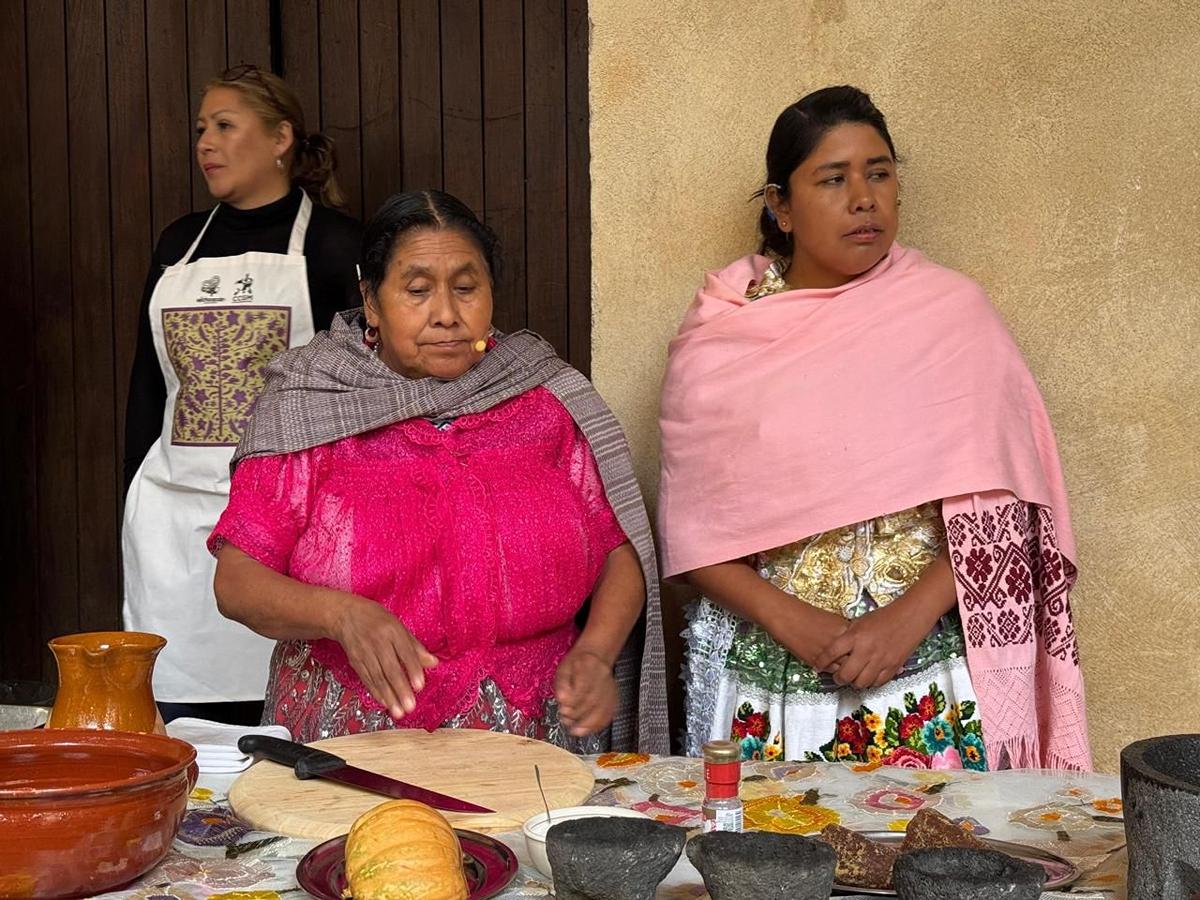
[589,0,1200,770]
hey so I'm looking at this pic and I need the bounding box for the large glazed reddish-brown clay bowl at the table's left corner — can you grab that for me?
[0,730,197,898]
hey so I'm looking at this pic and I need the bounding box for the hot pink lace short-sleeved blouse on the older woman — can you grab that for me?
[209,388,625,728]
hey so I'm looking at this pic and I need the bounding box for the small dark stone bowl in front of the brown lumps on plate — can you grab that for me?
[892,847,1046,900]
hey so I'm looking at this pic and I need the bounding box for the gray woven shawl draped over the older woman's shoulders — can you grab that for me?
[230,310,670,754]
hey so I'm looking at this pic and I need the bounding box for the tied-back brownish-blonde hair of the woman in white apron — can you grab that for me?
[204,65,346,209]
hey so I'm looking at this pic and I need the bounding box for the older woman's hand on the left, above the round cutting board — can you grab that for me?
[331,594,438,719]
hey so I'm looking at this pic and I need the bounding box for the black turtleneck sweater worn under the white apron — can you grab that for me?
[125,187,362,490]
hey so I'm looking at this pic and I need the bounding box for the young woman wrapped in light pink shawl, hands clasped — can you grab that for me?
[659,86,1091,769]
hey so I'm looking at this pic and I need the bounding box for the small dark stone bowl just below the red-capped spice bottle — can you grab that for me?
[688,832,838,900]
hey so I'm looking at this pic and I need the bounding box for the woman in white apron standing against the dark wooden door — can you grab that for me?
[121,66,361,722]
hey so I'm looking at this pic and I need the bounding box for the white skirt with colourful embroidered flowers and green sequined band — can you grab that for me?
[684,596,988,770]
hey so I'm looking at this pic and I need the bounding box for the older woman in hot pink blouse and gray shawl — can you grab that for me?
[209,191,666,751]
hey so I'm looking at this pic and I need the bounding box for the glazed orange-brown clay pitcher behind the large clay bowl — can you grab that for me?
[46,631,167,734]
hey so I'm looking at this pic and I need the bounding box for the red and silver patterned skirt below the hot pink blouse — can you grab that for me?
[263,641,610,754]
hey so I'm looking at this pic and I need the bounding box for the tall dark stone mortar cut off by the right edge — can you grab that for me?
[1121,734,1200,900]
